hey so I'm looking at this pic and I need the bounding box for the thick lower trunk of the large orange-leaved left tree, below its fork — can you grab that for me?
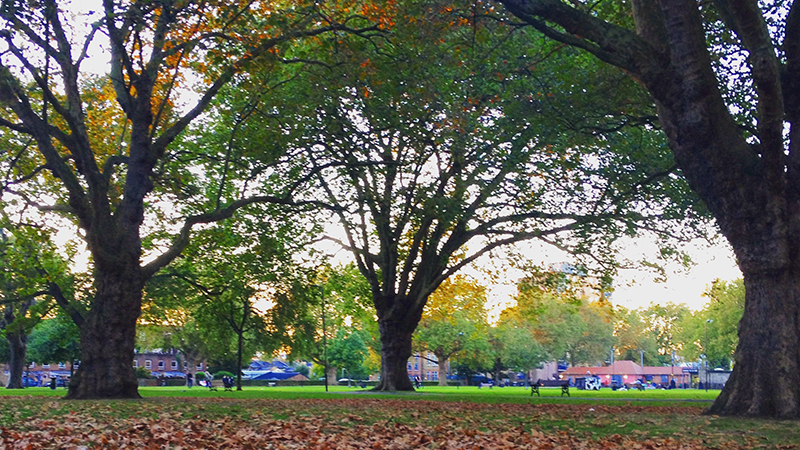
[66,268,143,399]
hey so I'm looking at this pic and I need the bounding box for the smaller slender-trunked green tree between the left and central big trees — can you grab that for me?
[147,214,315,390]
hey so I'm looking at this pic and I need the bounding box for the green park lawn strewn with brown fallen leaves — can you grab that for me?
[0,386,800,449]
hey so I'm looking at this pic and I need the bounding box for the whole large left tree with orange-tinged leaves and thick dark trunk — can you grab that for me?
[0,0,376,399]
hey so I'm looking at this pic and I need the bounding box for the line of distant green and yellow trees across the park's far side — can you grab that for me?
[2,265,744,385]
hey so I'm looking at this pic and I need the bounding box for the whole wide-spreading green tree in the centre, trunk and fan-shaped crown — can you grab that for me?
[250,2,687,390]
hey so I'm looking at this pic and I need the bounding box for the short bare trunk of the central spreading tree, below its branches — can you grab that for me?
[374,319,419,391]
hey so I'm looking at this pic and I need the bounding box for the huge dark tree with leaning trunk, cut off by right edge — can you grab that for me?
[500,0,800,418]
